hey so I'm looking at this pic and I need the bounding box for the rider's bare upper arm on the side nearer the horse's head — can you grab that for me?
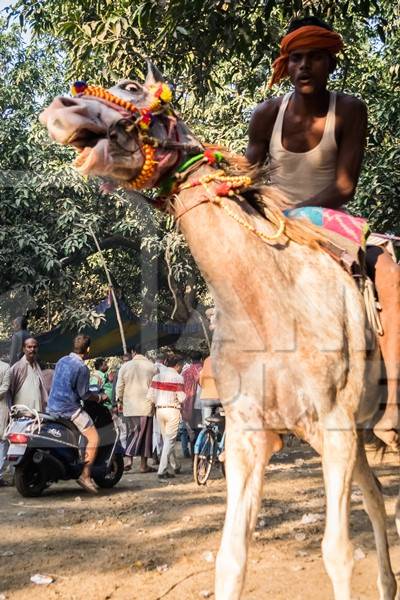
[246,98,280,165]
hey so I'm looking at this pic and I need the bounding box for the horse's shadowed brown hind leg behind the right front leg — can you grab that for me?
[354,432,397,600]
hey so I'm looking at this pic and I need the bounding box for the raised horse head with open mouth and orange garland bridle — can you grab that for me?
[40,63,203,189]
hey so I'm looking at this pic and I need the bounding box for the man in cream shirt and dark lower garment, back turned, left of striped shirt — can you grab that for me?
[116,348,157,473]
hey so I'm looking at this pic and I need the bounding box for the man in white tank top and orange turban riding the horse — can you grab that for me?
[246,17,400,447]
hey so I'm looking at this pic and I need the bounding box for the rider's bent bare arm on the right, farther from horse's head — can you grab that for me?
[298,97,368,209]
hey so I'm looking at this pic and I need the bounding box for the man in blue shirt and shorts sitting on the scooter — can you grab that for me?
[47,335,102,493]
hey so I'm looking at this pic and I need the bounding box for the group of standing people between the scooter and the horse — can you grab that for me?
[105,347,218,480]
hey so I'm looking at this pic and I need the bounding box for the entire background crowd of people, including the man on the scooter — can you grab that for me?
[0,319,218,492]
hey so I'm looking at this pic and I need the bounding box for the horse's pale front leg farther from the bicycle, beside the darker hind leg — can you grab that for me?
[322,409,357,600]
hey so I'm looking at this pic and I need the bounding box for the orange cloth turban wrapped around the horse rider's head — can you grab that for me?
[268,25,343,88]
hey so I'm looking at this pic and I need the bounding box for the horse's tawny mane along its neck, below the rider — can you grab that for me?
[206,144,329,249]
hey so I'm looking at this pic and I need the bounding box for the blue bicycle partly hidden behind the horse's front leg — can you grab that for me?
[193,415,225,485]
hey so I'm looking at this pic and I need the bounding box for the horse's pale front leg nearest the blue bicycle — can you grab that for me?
[215,422,282,600]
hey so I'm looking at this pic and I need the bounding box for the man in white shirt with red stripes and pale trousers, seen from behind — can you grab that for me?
[147,356,185,479]
